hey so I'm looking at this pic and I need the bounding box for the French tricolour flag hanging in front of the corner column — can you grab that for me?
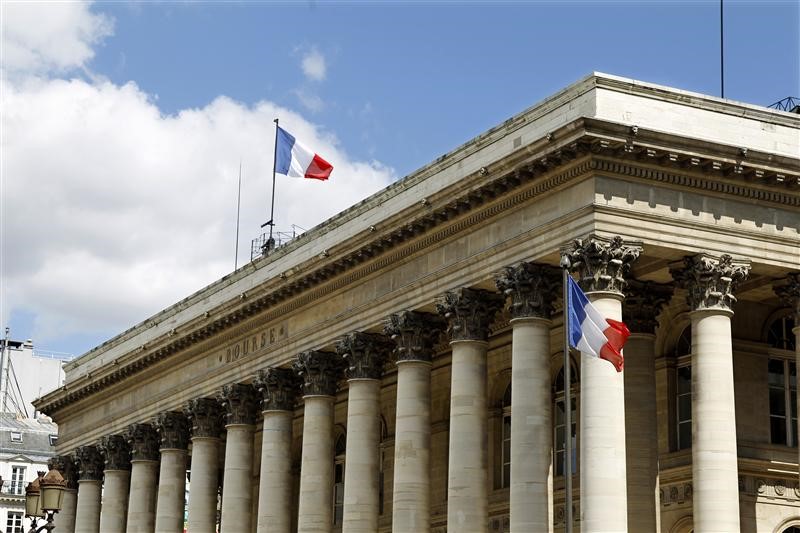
[566,276,631,372]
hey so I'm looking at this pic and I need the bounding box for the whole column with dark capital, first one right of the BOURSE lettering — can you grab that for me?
[294,350,341,533]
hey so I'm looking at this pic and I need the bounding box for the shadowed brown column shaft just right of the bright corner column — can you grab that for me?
[624,333,661,533]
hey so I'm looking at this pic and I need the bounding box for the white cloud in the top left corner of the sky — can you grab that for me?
[0,2,114,76]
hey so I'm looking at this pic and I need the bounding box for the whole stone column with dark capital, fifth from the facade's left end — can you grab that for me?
[155,411,189,533]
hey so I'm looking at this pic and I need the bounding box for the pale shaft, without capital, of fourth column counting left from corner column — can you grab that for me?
[392,360,431,533]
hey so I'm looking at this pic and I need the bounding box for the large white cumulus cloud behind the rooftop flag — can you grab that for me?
[0,4,394,349]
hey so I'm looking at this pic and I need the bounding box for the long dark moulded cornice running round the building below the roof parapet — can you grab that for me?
[35,118,800,417]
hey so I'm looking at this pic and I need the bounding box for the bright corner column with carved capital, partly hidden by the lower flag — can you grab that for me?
[564,236,641,533]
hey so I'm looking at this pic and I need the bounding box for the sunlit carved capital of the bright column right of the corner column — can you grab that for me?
[670,254,750,311]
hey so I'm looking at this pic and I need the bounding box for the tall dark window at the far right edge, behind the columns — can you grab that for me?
[767,359,797,446]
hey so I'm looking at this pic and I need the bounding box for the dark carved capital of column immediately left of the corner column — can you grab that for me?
[494,263,561,319]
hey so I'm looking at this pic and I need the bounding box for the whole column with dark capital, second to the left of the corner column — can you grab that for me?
[436,288,504,533]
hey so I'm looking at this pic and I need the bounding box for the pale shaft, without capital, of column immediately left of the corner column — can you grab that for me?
[510,318,553,533]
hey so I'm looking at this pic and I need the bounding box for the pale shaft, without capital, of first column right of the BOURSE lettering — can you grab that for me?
[297,396,333,533]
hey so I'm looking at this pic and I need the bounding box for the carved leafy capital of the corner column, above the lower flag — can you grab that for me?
[562,235,642,294]
